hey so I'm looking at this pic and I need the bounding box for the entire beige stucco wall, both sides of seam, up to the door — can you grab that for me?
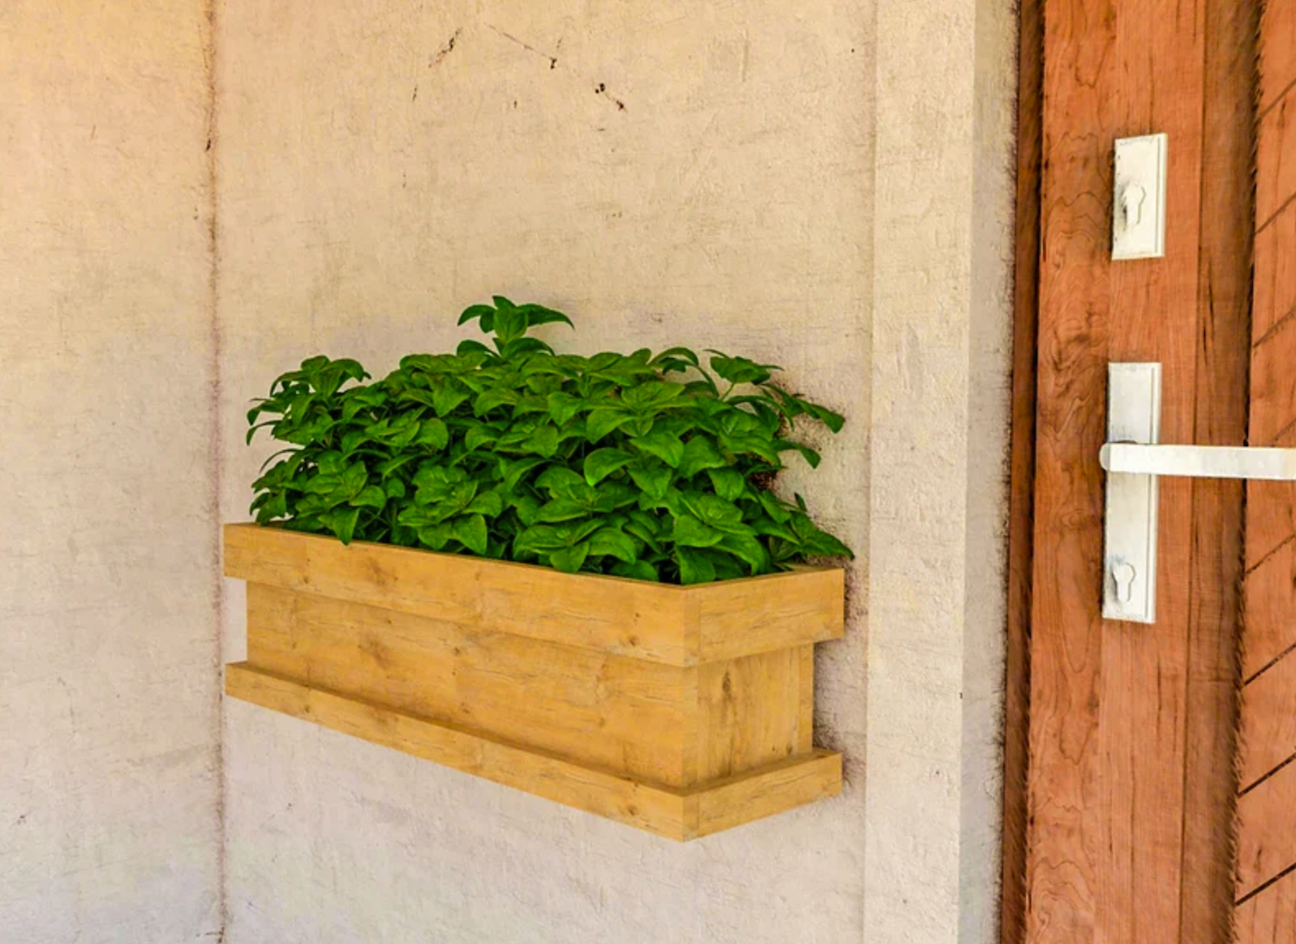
[0,0,1013,944]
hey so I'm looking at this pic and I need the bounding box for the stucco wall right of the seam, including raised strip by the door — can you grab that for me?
[216,0,1012,944]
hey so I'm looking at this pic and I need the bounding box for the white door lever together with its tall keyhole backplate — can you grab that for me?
[1098,363,1296,622]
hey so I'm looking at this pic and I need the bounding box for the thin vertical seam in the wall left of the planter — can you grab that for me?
[202,0,229,941]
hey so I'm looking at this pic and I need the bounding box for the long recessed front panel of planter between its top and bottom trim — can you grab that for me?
[248,584,697,786]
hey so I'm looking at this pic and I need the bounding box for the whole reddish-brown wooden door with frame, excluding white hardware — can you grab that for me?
[1004,0,1296,944]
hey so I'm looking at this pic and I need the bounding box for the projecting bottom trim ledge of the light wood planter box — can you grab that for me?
[226,663,841,842]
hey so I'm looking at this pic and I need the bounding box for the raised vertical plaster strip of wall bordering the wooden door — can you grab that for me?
[864,0,1015,944]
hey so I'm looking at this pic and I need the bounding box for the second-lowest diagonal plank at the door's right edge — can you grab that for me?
[1238,764,1296,897]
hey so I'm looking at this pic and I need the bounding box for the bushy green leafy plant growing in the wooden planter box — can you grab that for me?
[248,296,850,584]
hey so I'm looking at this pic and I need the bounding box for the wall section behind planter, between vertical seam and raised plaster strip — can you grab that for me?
[218,0,874,944]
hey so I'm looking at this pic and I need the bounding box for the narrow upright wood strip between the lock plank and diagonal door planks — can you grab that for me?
[1181,1,1260,941]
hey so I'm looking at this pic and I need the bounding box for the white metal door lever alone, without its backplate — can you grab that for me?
[1098,442,1296,482]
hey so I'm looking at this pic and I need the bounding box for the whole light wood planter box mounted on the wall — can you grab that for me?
[224,524,844,840]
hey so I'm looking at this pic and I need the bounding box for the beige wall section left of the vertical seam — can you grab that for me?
[0,0,220,944]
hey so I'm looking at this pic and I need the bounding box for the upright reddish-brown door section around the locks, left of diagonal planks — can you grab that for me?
[1026,0,1255,944]
